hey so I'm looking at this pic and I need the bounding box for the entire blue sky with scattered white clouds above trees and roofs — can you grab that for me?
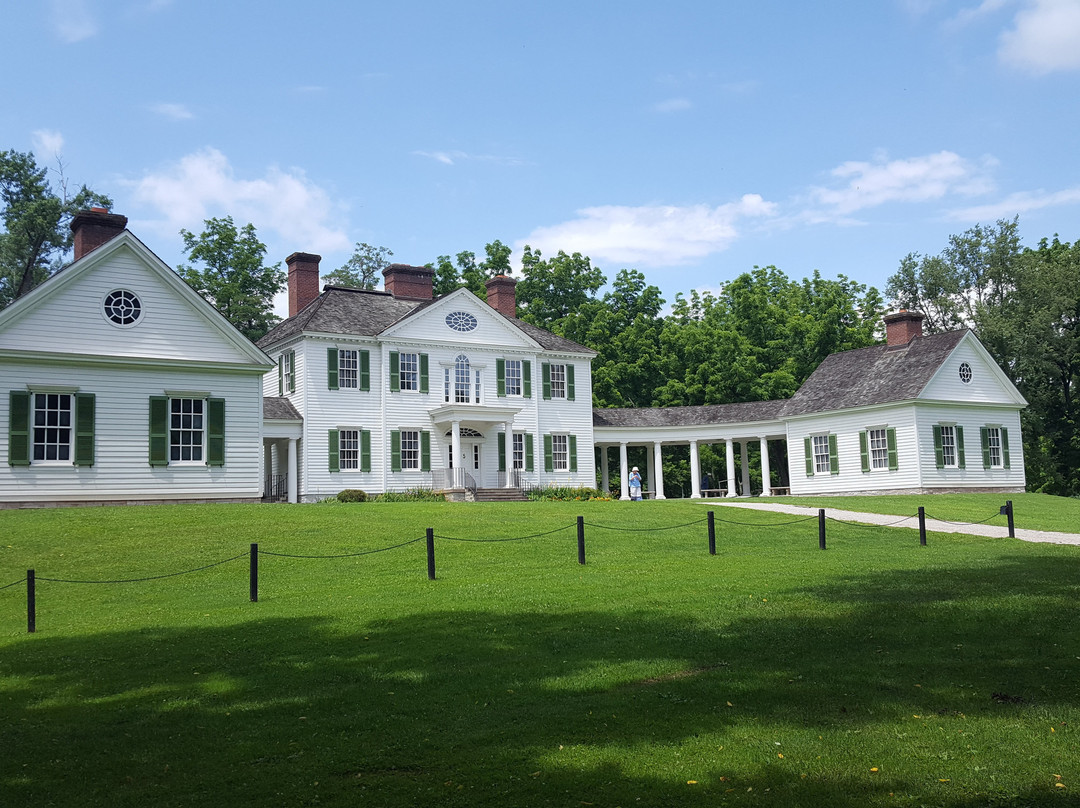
[6,0,1080,315]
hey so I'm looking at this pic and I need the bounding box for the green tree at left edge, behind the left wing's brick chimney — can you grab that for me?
[0,150,112,308]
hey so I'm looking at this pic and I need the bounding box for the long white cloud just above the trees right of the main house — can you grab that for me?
[516,193,777,267]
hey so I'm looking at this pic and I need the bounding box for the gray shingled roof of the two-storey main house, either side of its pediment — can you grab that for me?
[258,286,595,354]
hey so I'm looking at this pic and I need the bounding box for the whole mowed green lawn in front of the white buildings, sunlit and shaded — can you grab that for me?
[0,497,1080,808]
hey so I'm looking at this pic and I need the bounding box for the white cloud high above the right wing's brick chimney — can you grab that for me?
[807,151,994,219]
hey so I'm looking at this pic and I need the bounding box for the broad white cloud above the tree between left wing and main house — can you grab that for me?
[127,148,352,253]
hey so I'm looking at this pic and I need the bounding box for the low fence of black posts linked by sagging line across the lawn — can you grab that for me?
[0,500,1016,634]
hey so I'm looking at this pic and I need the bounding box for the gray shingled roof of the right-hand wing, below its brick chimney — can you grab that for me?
[782,331,968,416]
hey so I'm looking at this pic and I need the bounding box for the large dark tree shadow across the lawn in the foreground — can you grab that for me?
[0,555,1080,808]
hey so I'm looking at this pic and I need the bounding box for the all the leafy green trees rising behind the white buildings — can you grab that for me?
[0,151,1080,496]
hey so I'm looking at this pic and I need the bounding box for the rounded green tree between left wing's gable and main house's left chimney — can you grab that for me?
[176,216,285,341]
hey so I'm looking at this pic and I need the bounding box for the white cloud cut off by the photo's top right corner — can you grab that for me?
[998,0,1080,75]
